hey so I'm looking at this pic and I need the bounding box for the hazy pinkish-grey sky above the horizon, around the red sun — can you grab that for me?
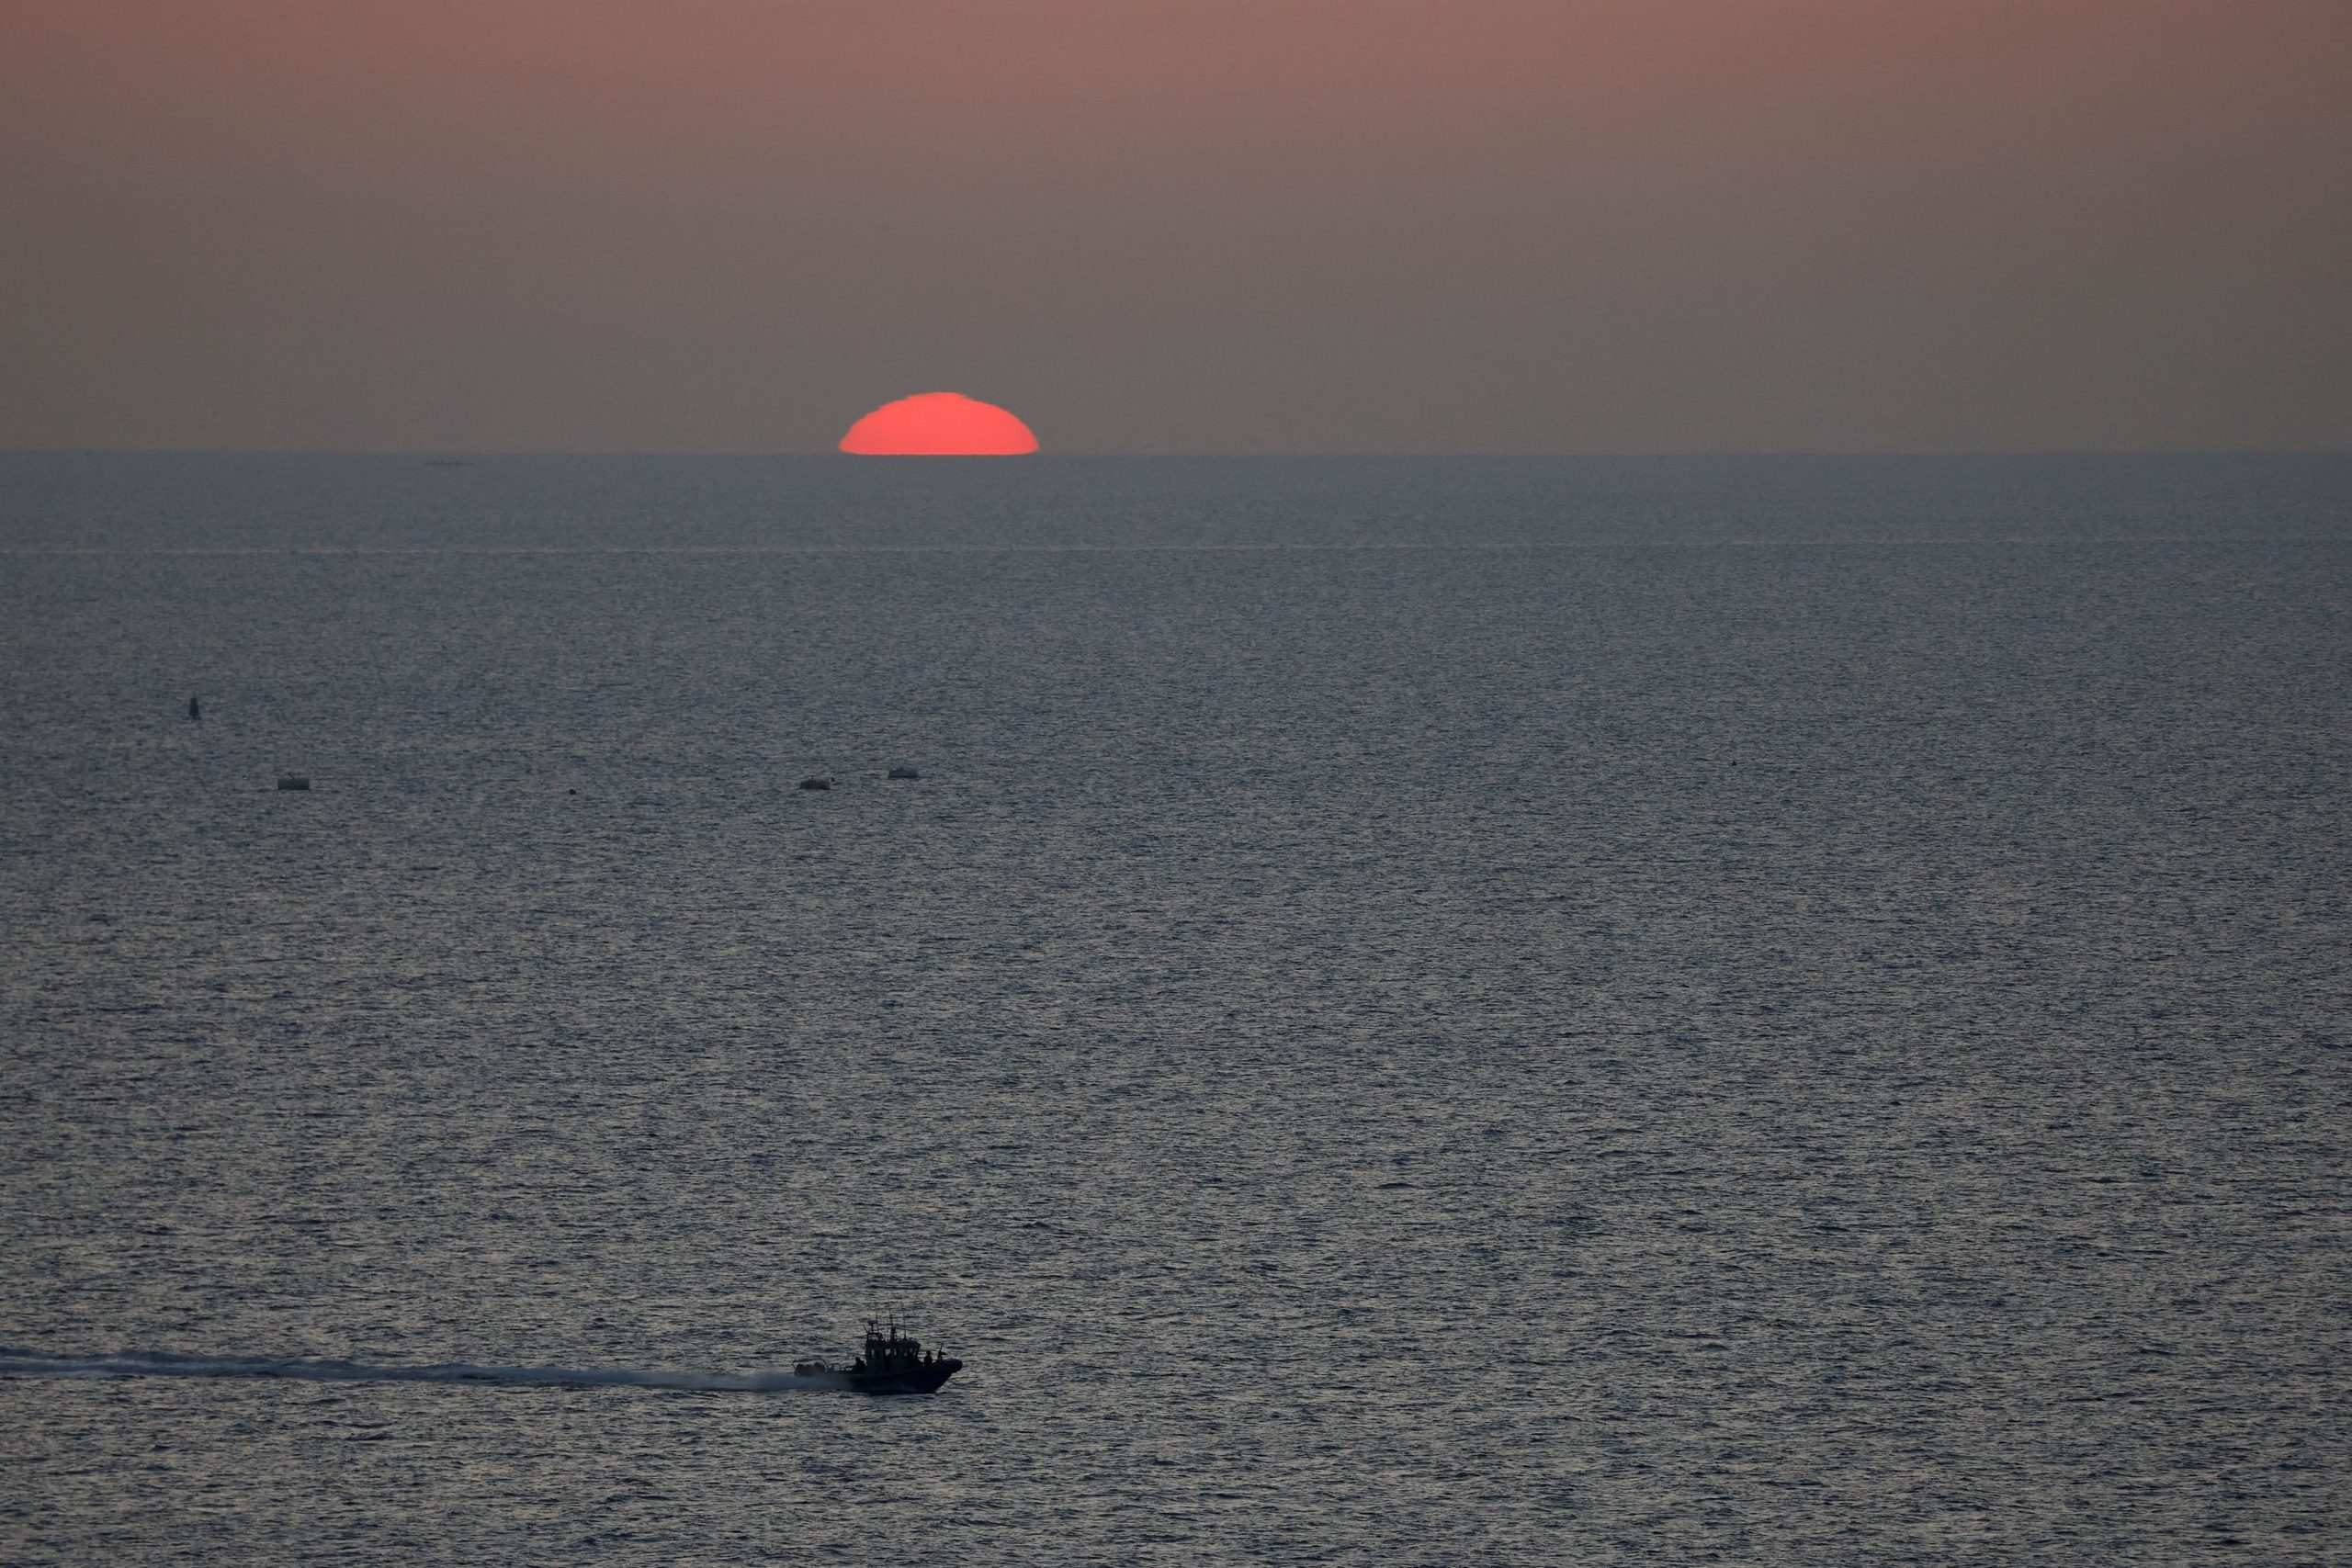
[0,0,2352,451]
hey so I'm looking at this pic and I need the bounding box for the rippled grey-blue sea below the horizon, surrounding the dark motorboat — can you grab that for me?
[0,454,2352,1568]
